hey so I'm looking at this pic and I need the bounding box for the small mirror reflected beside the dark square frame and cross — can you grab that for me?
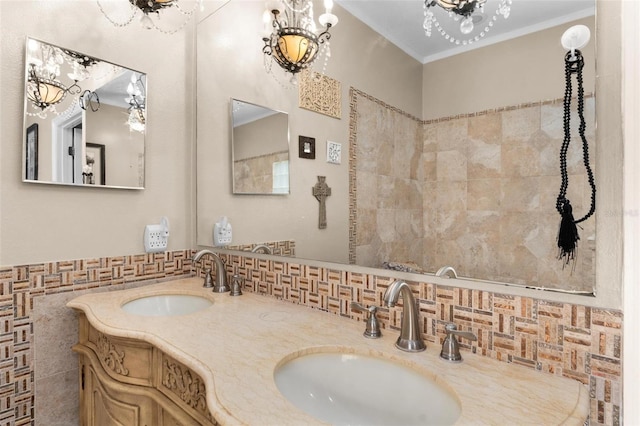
[230,99,289,195]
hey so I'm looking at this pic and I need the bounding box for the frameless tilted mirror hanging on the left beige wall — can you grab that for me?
[22,38,147,189]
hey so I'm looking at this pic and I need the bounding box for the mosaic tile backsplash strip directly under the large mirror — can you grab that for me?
[226,255,622,425]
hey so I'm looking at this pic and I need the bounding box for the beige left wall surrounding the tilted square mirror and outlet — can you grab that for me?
[0,0,195,265]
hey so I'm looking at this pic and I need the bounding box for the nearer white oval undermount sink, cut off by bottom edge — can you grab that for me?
[274,352,461,425]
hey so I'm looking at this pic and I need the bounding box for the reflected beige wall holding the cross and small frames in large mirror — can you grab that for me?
[197,1,422,263]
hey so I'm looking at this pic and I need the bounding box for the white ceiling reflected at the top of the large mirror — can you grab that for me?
[335,0,595,64]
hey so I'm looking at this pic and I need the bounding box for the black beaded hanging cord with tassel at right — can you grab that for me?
[556,49,596,267]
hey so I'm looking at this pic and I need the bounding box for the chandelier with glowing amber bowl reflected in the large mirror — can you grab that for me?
[262,0,338,79]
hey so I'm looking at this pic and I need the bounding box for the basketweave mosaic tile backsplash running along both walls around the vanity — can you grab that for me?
[0,250,622,426]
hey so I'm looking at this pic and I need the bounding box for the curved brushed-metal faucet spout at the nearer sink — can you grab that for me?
[383,280,427,352]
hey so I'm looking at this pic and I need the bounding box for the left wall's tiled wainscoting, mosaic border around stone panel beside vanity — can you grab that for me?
[0,250,192,426]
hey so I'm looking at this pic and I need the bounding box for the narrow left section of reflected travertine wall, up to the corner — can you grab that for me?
[349,89,429,267]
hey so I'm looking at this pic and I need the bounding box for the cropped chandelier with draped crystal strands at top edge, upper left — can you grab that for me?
[96,0,203,34]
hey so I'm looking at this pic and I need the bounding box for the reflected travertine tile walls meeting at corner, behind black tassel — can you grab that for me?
[350,89,597,292]
